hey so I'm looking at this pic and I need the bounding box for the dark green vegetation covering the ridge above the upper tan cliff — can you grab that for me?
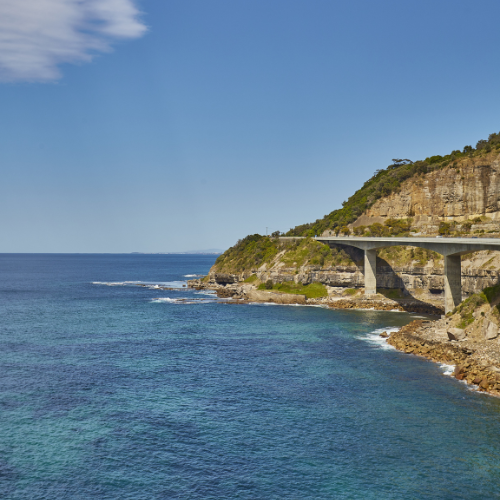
[286,132,500,236]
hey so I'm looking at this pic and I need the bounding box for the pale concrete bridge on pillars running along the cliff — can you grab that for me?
[280,236,500,313]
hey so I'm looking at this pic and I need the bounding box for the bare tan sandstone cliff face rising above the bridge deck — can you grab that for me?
[352,152,500,234]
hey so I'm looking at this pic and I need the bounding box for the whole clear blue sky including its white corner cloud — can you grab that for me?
[0,0,500,253]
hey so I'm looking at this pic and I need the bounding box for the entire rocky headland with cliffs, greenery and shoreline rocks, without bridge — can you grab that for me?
[194,133,500,395]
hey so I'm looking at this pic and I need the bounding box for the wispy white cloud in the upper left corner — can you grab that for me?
[0,0,146,81]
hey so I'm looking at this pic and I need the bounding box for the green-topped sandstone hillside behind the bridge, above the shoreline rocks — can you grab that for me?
[203,134,500,302]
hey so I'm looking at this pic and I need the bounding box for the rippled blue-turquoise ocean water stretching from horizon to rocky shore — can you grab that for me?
[0,254,500,500]
